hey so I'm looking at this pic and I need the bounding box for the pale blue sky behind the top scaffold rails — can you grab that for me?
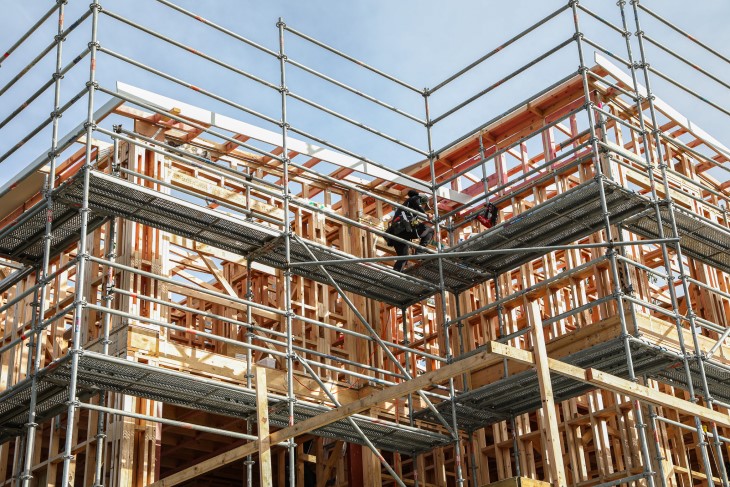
[0,0,730,189]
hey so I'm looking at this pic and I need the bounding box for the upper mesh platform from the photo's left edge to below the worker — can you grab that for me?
[0,171,438,306]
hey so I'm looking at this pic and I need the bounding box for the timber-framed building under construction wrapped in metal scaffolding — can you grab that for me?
[0,0,730,487]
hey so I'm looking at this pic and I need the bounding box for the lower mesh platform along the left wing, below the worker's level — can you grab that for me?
[0,352,451,452]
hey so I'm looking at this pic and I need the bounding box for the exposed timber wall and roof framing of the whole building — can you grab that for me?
[0,41,730,487]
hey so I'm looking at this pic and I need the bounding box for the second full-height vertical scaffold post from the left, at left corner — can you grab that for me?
[61,0,101,487]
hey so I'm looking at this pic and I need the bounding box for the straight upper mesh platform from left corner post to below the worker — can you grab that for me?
[48,171,438,306]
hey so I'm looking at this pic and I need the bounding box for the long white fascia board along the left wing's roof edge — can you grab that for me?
[112,81,471,203]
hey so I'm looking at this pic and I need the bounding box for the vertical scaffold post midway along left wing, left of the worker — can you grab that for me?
[276,17,297,487]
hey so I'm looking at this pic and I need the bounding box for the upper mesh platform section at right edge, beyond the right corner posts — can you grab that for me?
[624,205,730,273]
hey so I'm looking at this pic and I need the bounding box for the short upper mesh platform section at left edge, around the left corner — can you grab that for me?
[0,201,105,264]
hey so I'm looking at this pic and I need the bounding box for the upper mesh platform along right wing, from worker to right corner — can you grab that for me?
[406,179,650,292]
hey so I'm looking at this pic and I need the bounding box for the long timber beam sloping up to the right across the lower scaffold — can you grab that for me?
[150,343,502,487]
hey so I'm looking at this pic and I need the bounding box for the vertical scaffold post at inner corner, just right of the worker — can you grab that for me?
[423,88,464,487]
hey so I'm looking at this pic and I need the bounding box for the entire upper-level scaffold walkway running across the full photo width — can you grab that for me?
[0,171,730,307]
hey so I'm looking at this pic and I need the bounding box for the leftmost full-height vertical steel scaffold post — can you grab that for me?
[21,0,67,487]
